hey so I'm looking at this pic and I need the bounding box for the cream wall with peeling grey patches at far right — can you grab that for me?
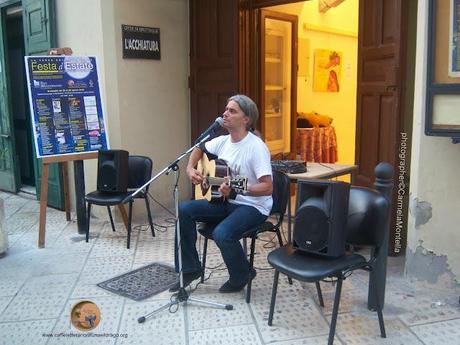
[406,0,460,287]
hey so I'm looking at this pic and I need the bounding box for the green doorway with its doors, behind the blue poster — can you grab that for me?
[0,0,64,210]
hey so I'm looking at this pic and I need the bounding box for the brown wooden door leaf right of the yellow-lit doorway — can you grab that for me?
[354,0,407,187]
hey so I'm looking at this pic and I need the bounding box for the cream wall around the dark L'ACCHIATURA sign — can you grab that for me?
[114,0,190,218]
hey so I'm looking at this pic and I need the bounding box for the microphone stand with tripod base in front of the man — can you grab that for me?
[132,134,233,323]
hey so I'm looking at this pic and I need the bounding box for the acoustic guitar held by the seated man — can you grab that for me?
[195,154,248,201]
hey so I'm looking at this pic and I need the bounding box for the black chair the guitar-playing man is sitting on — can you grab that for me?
[198,171,292,303]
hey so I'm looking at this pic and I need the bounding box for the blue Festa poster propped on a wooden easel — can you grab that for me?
[24,56,109,158]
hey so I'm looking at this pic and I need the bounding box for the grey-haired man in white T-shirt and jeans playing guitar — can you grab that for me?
[170,95,273,293]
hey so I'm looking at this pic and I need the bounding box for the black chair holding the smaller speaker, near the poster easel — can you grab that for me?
[85,156,155,249]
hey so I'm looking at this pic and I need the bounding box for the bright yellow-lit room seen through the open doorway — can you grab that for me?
[261,1,359,168]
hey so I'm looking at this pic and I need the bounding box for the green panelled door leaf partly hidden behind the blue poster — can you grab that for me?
[22,0,64,210]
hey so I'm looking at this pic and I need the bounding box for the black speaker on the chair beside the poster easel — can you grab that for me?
[97,150,129,193]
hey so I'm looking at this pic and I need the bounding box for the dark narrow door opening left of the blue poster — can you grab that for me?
[5,5,36,194]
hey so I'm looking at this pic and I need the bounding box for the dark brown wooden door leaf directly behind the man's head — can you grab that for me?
[189,0,239,142]
